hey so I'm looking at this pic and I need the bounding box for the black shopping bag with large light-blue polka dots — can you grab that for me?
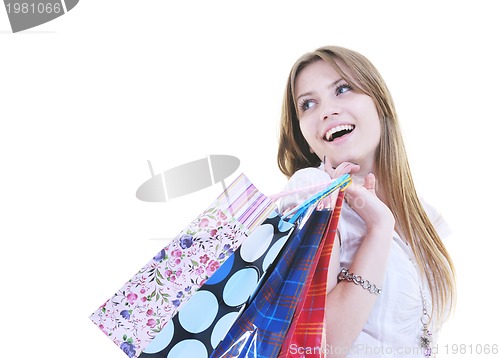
[140,174,352,358]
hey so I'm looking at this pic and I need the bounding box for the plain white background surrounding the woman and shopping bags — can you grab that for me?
[0,0,500,357]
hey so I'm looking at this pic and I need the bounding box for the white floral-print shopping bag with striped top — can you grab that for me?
[90,174,275,358]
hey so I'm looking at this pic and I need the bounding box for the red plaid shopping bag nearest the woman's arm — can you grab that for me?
[279,191,344,358]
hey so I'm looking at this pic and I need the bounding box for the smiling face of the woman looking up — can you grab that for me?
[294,60,381,172]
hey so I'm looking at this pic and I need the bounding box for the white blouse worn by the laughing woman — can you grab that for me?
[338,201,449,358]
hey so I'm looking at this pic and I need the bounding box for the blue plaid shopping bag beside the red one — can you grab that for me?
[211,176,350,358]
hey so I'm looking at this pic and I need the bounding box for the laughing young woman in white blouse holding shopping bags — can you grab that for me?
[278,46,455,357]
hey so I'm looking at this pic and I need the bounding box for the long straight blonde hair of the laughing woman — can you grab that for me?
[278,46,455,324]
